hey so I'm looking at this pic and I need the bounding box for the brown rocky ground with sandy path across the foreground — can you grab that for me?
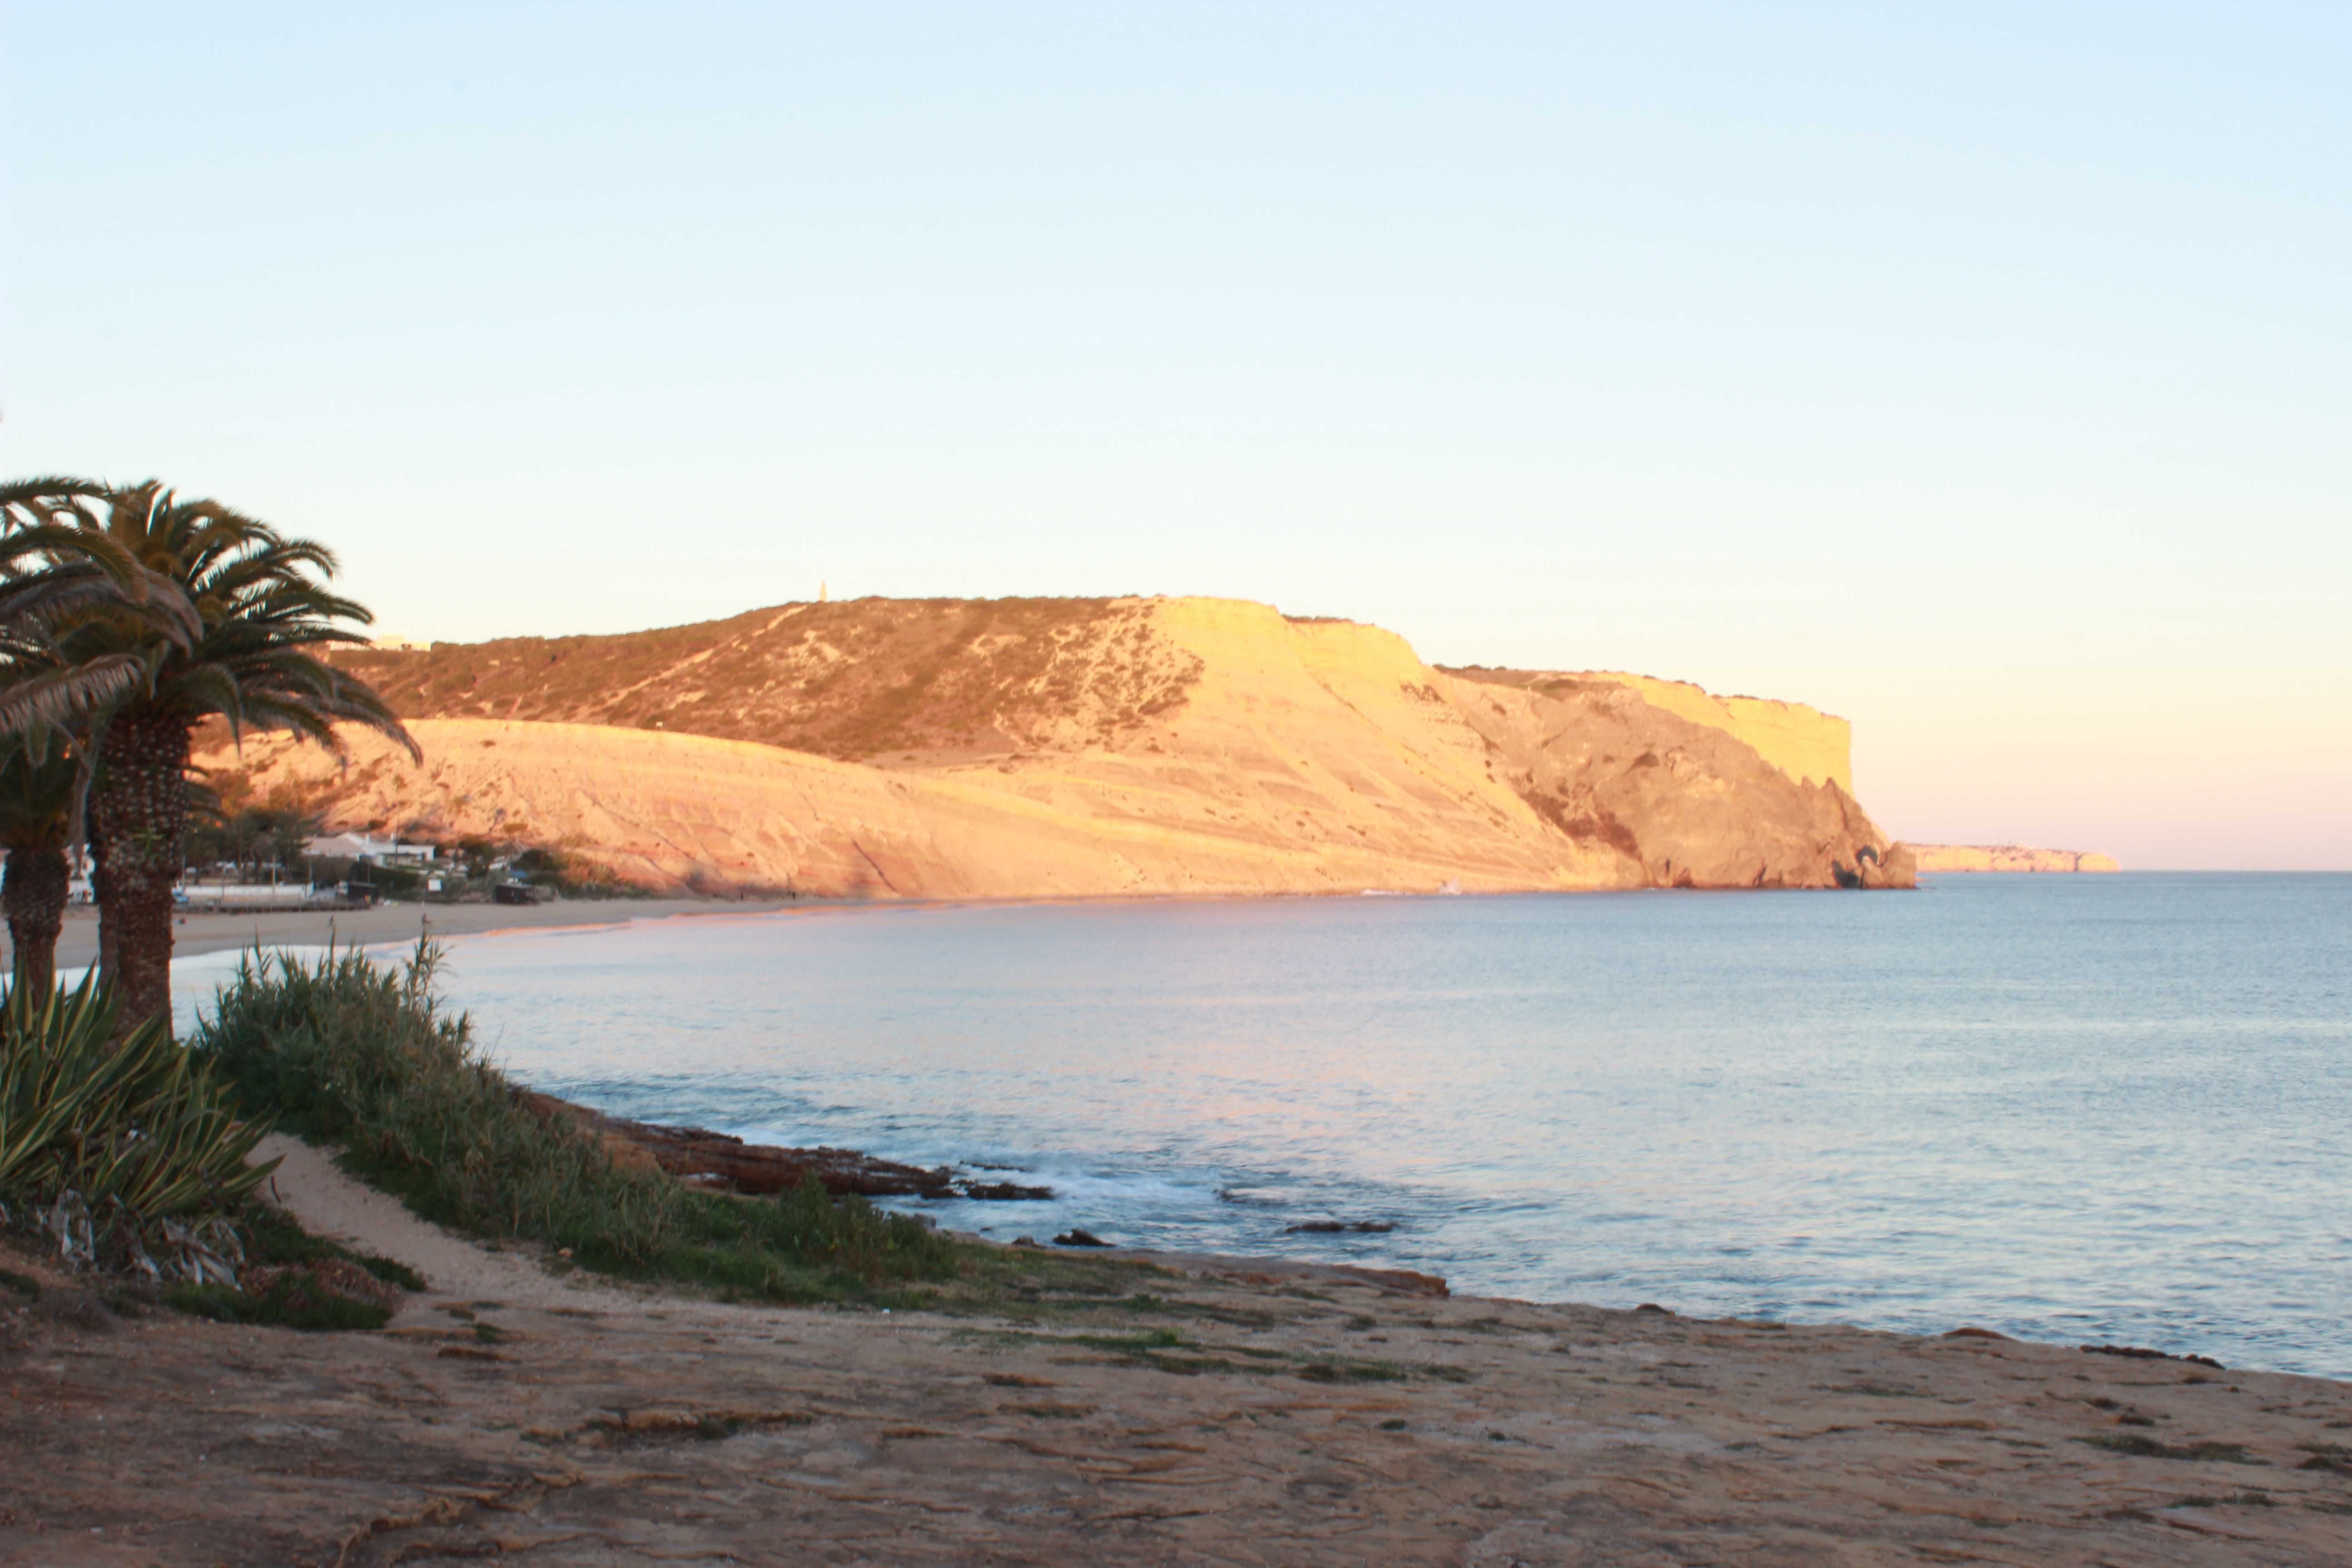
[0,1159,2352,1568]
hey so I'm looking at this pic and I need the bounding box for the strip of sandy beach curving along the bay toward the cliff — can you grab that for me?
[39,898,811,969]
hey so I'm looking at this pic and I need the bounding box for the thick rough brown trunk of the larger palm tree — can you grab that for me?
[89,708,188,1032]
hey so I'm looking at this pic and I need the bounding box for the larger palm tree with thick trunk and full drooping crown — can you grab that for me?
[41,480,421,1027]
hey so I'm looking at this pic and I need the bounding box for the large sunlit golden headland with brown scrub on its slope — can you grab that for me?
[200,599,1912,898]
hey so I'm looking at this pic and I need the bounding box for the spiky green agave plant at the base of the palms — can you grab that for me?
[0,975,278,1258]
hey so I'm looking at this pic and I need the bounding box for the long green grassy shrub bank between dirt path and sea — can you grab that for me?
[191,943,955,1300]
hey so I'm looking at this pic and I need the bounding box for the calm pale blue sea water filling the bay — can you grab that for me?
[181,874,2352,1375]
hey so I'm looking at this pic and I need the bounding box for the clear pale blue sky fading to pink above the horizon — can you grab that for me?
[0,0,2352,870]
